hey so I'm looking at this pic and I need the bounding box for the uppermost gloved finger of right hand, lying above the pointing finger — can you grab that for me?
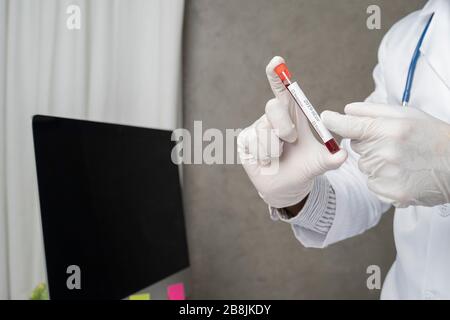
[345,102,419,119]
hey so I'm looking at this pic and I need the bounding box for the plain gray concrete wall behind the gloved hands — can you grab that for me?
[184,0,424,299]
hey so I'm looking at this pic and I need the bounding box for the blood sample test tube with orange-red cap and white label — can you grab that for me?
[274,63,340,154]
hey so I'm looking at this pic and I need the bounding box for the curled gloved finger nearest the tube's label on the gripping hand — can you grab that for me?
[266,99,298,143]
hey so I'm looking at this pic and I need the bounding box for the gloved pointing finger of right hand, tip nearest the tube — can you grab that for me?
[321,111,376,140]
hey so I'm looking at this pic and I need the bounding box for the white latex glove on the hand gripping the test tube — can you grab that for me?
[238,57,347,208]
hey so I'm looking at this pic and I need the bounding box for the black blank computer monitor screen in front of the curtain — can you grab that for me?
[33,116,189,299]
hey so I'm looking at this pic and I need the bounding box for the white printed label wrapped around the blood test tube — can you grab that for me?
[288,82,333,143]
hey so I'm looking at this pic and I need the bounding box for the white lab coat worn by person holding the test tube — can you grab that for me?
[294,0,450,299]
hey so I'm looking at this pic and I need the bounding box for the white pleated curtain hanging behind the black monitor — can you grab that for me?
[0,0,184,299]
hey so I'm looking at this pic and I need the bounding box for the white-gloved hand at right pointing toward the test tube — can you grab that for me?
[322,103,450,207]
